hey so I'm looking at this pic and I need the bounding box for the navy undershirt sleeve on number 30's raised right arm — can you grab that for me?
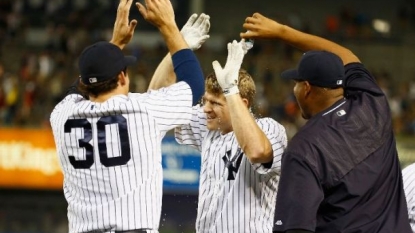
[172,49,205,105]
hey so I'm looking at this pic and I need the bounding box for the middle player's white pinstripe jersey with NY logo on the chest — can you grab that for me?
[175,105,287,233]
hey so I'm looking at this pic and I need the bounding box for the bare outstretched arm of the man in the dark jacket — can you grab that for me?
[240,13,360,64]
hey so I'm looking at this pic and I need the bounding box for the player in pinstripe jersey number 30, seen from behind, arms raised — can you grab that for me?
[50,0,208,233]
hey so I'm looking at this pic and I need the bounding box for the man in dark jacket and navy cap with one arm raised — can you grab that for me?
[241,13,411,233]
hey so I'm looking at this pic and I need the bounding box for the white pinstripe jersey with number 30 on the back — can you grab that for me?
[50,82,192,233]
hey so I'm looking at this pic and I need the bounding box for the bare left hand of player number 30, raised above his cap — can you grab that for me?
[110,0,137,49]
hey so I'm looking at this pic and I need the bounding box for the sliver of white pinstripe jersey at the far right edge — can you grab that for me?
[402,163,415,233]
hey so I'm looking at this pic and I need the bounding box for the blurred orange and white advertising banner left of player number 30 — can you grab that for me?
[0,129,63,189]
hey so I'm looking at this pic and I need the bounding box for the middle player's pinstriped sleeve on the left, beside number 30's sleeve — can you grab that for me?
[174,105,207,151]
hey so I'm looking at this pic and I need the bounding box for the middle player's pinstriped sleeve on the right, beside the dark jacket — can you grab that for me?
[252,118,287,174]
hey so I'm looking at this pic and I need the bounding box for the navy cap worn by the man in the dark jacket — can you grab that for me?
[281,51,345,88]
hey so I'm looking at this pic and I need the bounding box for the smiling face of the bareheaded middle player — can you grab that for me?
[203,92,232,134]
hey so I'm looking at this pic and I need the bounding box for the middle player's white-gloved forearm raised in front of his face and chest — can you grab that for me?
[212,41,273,163]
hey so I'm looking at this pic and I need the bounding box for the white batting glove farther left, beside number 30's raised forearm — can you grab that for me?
[180,13,210,50]
